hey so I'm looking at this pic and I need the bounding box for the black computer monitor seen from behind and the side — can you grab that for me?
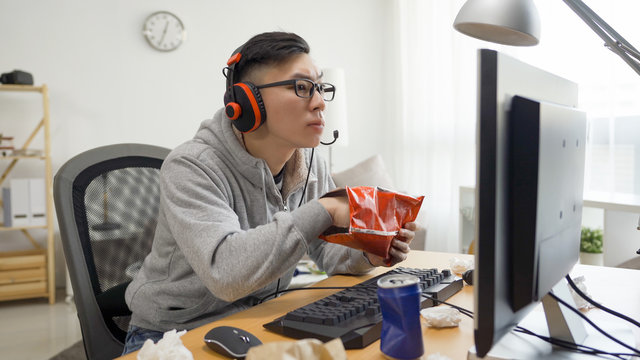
[473,49,586,357]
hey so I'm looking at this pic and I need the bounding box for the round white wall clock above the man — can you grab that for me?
[142,11,186,51]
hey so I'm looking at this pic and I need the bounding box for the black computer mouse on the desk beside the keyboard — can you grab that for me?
[204,326,262,359]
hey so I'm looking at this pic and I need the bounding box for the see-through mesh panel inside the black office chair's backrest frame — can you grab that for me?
[84,168,160,292]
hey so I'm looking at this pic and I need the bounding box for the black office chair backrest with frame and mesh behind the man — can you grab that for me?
[53,144,169,359]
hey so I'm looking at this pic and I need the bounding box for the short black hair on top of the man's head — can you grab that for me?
[233,31,310,82]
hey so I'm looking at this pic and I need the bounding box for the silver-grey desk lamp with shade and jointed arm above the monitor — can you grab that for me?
[453,0,640,75]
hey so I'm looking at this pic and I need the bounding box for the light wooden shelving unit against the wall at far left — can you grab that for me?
[0,85,55,304]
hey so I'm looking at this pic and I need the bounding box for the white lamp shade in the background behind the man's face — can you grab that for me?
[322,68,349,146]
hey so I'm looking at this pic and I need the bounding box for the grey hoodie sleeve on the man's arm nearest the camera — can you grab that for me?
[161,156,331,302]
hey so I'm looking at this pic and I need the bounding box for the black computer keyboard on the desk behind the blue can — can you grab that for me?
[263,267,463,349]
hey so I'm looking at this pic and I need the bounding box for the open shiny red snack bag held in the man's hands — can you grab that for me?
[320,186,424,259]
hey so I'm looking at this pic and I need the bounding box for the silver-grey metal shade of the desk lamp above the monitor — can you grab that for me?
[453,0,540,46]
